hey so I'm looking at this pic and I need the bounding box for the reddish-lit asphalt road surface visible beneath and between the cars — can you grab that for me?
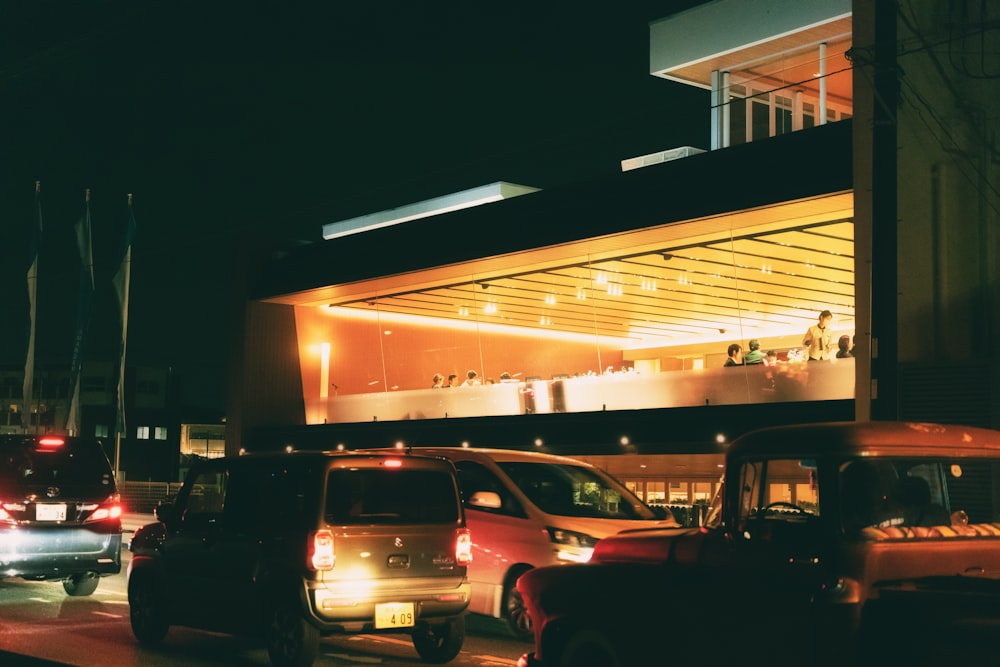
[0,515,530,667]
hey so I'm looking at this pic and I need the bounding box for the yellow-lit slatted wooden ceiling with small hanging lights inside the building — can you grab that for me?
[330,219,854,344]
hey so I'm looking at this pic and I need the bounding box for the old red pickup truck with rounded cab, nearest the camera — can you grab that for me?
[517,422,1000,667]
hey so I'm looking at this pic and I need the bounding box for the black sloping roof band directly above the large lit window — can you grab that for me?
[251,121,852,299]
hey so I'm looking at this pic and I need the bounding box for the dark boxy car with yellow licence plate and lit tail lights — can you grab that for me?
[128,452,471,665]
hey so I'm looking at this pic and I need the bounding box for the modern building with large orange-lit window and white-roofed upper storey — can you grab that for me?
[226,0,1000,488]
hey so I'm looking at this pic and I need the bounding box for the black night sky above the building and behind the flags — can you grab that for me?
[0,0,708,411]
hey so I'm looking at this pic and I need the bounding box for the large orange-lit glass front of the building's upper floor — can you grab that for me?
[296,195,855,424]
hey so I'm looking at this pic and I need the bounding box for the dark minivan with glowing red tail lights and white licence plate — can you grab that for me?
[0,435,122,595]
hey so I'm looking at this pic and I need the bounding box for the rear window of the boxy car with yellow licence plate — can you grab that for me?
[326,468,460,526]
